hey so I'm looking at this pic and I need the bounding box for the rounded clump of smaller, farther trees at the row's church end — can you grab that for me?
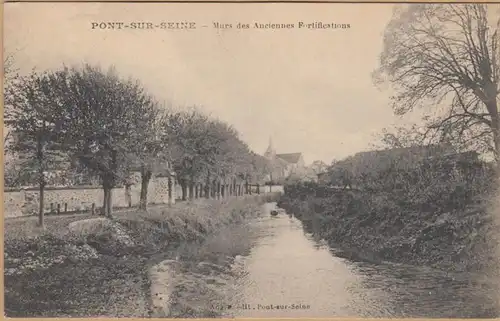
[164,109,253,200]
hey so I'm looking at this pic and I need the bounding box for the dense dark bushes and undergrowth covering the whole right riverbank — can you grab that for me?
[280,153,496,271]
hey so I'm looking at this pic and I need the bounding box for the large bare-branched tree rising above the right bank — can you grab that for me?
[374,4,500,160]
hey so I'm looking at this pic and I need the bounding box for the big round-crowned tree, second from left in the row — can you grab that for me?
[50,64,154,217]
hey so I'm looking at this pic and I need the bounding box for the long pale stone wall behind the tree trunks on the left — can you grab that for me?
[4,177,180,217]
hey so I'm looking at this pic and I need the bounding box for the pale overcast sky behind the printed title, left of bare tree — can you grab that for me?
[4,3,426,163]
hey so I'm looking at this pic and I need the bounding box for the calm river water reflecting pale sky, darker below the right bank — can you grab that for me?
[227,204,498,317]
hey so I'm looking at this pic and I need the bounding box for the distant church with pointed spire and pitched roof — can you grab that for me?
[264,139,306,183]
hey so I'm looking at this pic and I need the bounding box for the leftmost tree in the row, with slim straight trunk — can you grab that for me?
[4,72,64,227]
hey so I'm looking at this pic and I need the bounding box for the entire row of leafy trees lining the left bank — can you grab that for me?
[4,64,267,225]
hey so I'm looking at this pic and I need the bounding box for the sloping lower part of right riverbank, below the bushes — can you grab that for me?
[279,186,497,273]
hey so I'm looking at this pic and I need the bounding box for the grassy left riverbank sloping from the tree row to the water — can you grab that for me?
[5,191,282,317]
